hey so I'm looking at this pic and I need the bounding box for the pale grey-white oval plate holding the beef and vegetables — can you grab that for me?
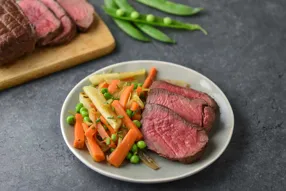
[61,60,234,183]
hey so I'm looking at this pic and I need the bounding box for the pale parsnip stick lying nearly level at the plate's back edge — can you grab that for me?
[89,69,146,85]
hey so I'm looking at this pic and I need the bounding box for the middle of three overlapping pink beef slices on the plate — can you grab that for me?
[147,89,216,131]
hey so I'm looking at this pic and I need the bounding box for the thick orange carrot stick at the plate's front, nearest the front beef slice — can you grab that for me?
[108,129,138,167]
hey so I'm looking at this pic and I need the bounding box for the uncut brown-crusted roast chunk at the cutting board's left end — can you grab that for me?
[0,0,36,65]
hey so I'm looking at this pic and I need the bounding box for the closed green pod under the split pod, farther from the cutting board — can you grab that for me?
[115,0,175,43]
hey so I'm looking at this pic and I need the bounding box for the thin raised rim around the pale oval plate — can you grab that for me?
[60,60,235,184]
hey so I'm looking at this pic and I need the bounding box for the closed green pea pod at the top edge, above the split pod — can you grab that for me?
[137,0,203,16]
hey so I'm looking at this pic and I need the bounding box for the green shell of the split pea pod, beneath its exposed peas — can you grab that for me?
[103,7,207,35]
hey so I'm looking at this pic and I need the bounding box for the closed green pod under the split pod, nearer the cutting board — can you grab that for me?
[104,0,150,42]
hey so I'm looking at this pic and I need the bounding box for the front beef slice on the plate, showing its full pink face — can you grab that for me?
[142,104,208,163]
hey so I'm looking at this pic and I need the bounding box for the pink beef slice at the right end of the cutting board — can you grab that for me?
[57,0,94,32]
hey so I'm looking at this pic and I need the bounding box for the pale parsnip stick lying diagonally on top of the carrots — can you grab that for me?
[83,86,122,131]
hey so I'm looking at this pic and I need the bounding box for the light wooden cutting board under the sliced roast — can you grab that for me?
[0,14,115,91]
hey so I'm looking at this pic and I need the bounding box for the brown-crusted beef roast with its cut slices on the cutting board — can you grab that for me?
[0,0,94,65]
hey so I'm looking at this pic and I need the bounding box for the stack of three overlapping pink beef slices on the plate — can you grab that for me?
[142,81,218,163]
